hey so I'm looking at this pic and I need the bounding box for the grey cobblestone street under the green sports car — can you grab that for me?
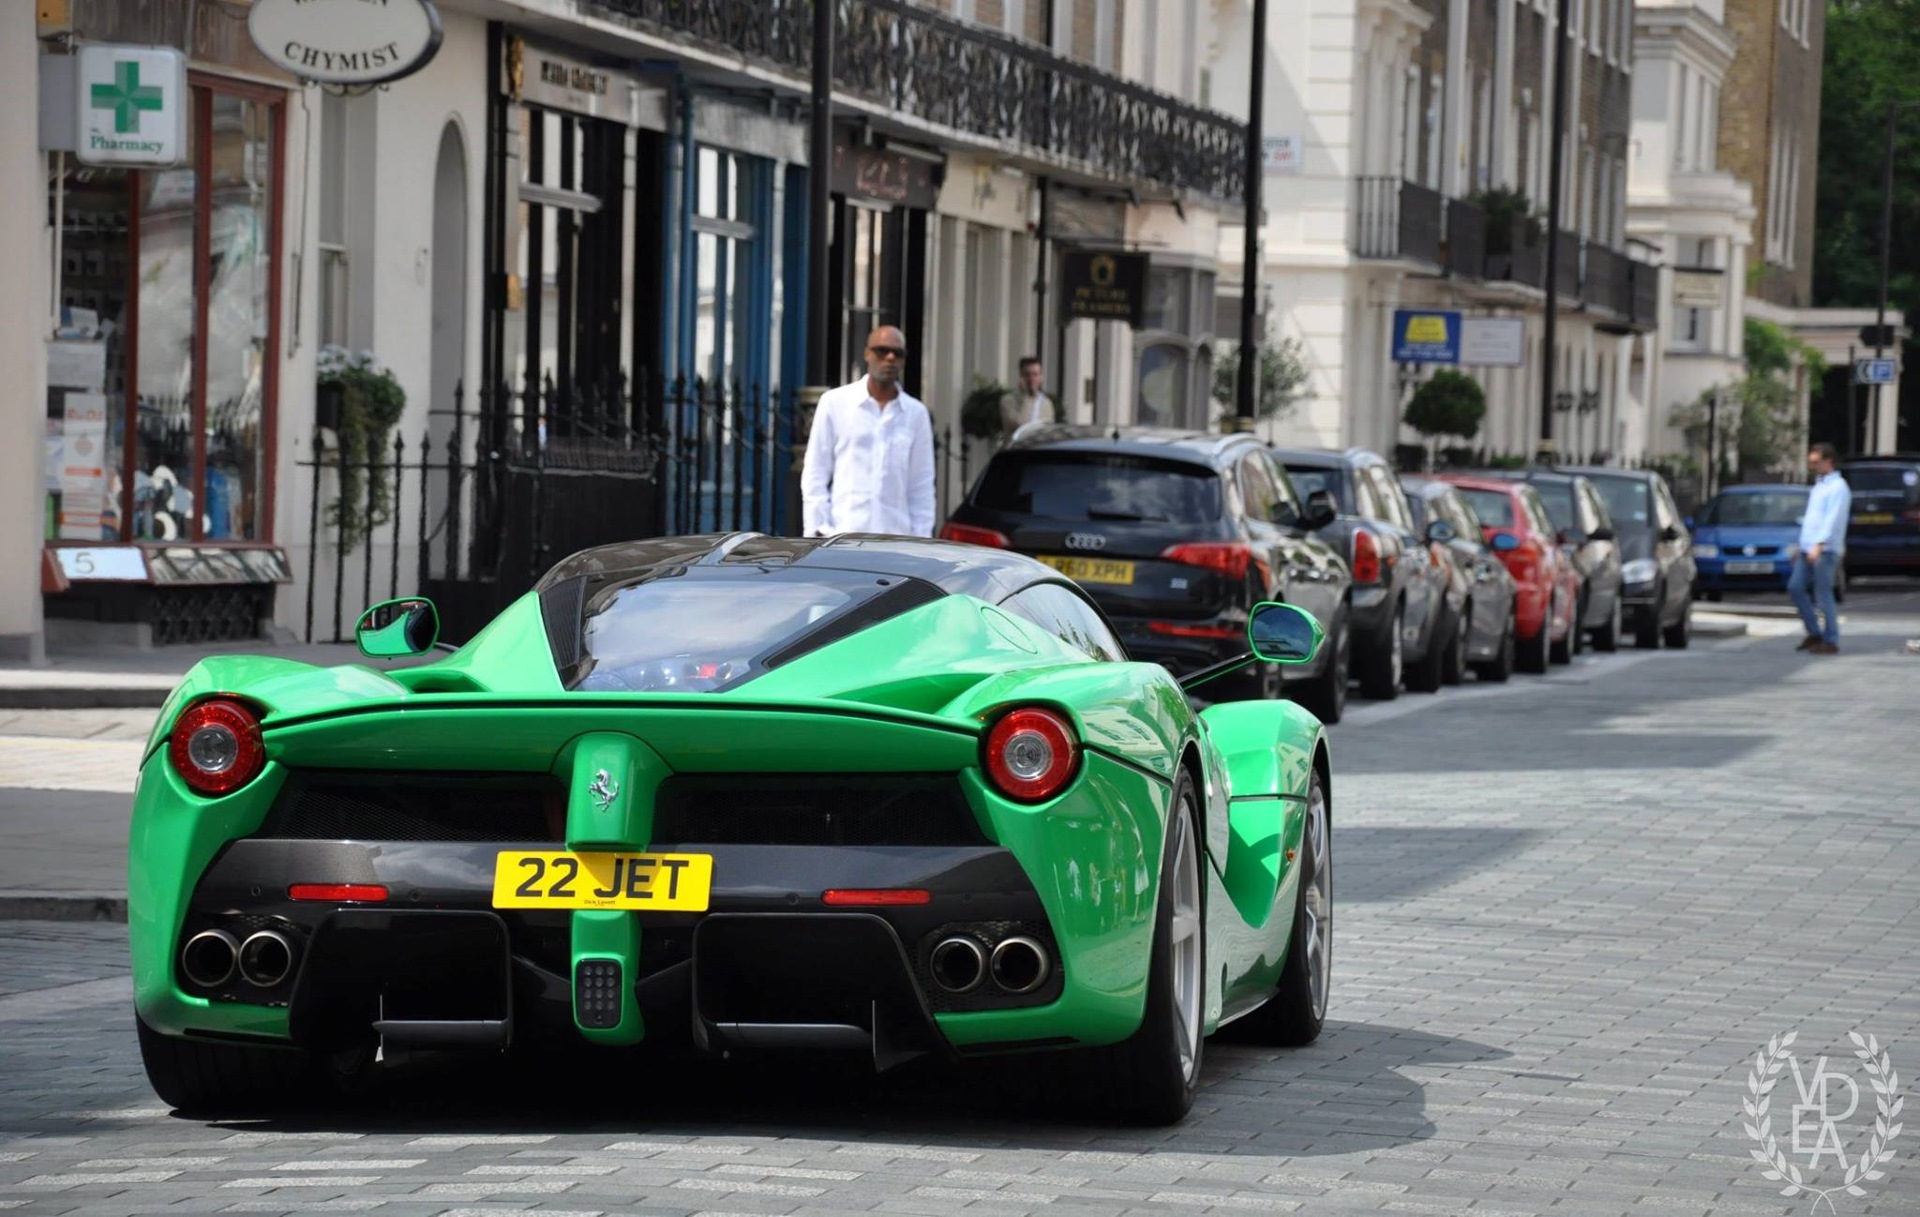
[0,591,1920,1217]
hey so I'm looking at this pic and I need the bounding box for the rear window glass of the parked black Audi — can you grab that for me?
[973,455,1221,524]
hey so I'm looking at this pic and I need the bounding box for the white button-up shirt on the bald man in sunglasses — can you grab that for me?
[801,376,933,537]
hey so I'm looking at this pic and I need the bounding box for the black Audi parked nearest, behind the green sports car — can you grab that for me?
[941,426,1350,722]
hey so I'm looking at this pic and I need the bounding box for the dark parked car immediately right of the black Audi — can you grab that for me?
[1275,447,1452,699]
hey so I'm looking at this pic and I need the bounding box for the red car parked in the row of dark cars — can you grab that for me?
[1432,474,1580,672]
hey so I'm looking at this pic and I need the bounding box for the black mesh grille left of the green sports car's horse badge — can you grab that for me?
[259,774,566,841]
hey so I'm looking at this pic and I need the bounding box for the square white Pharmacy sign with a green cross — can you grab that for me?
[73,44,190,165]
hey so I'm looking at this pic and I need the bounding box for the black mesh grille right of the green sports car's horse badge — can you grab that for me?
[653,774,989,845]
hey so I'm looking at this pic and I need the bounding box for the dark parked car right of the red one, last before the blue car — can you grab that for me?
[1559,466,1695,649]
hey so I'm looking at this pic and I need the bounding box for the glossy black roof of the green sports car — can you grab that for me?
[534,532,1066,603]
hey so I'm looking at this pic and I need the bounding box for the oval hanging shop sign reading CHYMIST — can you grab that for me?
[246,0,442,84]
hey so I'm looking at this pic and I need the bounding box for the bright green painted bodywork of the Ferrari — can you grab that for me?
[129,595,1325,1046]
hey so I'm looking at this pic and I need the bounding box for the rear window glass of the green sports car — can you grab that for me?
[563,566,939,693]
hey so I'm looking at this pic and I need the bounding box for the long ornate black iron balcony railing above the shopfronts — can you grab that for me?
[580,0,1246,202]
